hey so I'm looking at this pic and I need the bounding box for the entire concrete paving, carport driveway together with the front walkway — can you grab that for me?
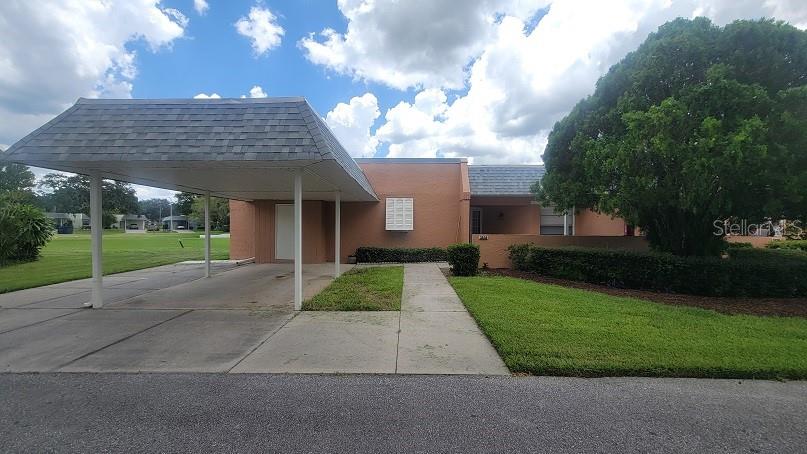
[0,263,508,375]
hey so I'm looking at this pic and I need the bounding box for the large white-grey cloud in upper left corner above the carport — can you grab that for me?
[0,0,187,142]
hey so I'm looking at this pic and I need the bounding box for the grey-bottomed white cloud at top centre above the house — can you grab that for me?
[299,0,546,89]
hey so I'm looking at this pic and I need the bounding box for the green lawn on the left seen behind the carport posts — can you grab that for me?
[0,231,230,293]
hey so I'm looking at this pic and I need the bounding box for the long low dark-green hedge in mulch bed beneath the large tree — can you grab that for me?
[509,245,807,297]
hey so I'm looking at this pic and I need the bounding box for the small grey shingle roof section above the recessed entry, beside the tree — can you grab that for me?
[468,165,544,196]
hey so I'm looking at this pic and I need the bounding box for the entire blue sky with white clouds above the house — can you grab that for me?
[0,0,807,198]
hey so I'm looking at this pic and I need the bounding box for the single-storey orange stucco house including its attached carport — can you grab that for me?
[0,97,644,309]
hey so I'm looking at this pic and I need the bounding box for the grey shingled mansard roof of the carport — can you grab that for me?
[0,97,375,197]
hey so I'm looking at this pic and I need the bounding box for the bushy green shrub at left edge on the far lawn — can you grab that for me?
[0,201,53,265]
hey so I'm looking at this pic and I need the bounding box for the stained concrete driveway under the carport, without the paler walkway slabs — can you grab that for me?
[0,263,344,372]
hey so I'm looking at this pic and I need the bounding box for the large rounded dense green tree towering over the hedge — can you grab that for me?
[534,18,807,255]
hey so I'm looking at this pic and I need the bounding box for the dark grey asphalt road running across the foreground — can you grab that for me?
[0,374,807,453]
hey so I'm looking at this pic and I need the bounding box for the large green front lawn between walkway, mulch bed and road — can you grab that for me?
[450,276,807,379]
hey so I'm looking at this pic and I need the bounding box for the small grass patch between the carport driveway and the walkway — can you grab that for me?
[303,266,403,311]
